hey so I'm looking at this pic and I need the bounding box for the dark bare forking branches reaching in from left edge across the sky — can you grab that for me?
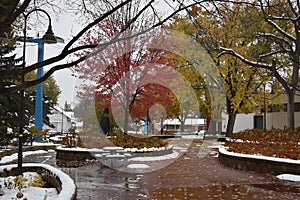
[0,0,220,93]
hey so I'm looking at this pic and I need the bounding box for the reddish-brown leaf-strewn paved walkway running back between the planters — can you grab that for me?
[140,140,300,200]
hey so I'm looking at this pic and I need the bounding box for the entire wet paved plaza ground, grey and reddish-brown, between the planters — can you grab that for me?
[2,139,300,200]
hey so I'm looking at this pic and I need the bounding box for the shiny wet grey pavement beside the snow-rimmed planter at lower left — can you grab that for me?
[63,166,148,200]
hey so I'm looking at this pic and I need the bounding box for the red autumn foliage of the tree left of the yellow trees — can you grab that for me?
[76,16,183,132]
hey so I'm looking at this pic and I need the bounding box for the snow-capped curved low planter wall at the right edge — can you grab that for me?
[219,147,300,175]
